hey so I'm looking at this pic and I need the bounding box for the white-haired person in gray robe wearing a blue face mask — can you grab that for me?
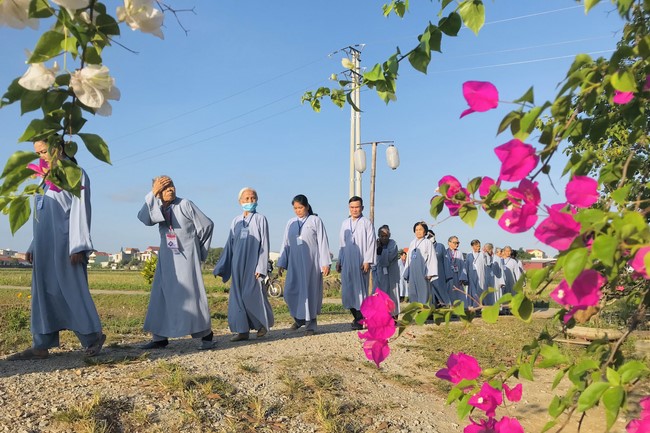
[213,187,274,341]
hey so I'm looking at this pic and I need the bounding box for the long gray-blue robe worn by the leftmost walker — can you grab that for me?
[27,171,102,334]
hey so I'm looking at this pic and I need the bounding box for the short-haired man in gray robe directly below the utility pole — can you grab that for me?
[336,196,377,330]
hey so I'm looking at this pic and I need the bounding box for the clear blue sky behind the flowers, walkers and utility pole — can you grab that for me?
[0,0,621,255]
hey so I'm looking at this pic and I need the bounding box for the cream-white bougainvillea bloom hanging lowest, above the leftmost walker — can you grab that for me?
[70,65,120,116]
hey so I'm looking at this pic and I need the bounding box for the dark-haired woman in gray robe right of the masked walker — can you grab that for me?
[278,194,332,335]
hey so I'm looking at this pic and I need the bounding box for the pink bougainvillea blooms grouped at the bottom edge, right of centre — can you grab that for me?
[436,352,524,433]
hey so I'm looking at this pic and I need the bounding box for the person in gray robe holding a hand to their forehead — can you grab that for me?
[138,176,214,350]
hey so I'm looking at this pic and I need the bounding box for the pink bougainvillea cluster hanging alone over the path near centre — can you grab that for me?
[359,289,395,367]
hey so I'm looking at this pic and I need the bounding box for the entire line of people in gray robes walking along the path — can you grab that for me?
[7,140,521,360]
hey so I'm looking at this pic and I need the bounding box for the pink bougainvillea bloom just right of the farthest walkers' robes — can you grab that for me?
[551,269,607,310]
